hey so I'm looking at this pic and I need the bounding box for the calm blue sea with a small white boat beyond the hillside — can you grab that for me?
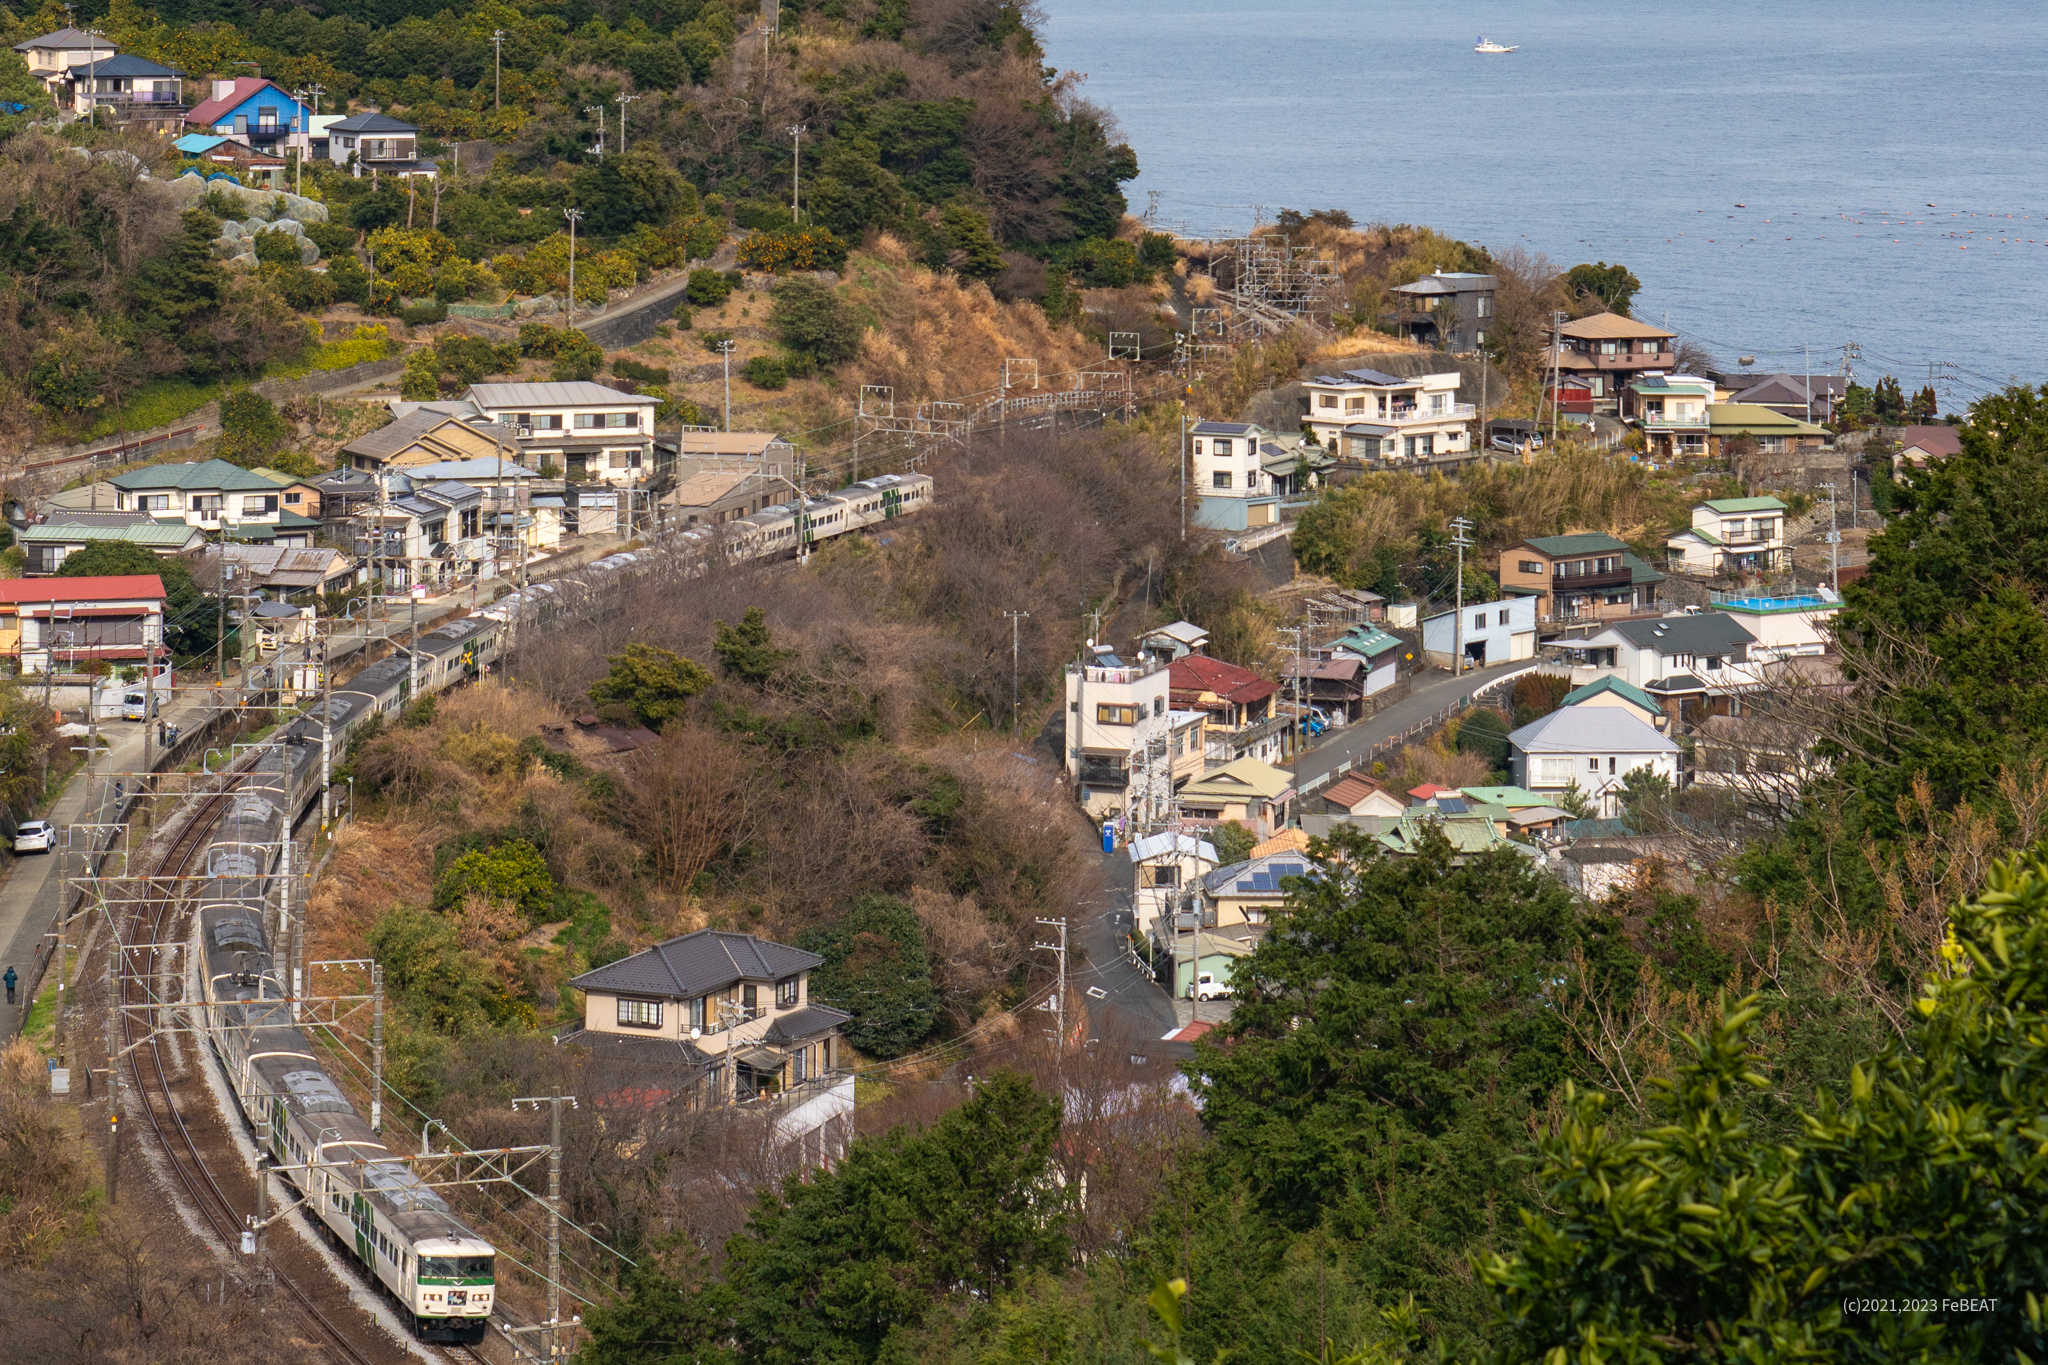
[1042,0,2048,411]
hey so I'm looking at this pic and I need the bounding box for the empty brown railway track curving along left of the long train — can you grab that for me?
[119,777,385,1365]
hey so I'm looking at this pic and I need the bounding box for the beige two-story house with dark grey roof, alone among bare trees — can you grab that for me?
[561,929,854,1158]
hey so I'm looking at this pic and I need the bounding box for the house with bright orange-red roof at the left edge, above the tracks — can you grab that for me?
[0,573,166,673]
